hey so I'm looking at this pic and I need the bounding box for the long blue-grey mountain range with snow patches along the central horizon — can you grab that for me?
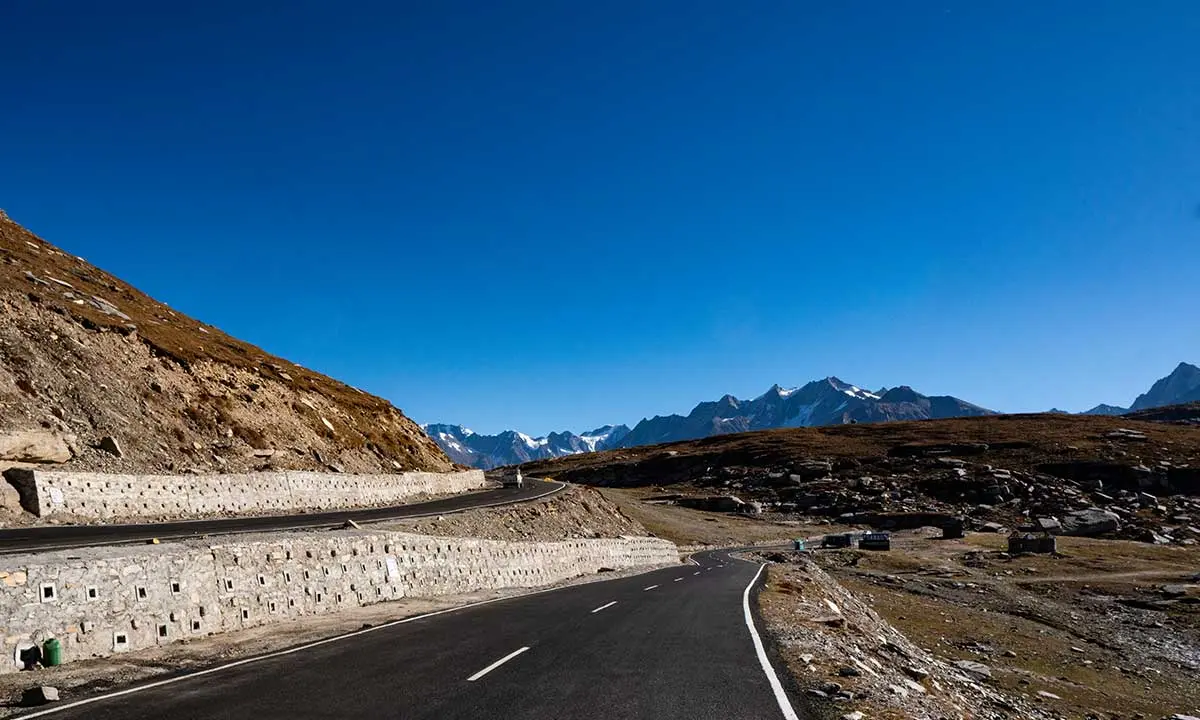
[422,377,994,469]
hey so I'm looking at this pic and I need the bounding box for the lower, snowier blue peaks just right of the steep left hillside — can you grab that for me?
[421,424,629,469]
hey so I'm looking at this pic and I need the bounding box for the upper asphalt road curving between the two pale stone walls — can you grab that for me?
[0,478,565,554]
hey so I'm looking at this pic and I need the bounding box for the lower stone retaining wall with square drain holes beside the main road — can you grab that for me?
[0,530,679,672]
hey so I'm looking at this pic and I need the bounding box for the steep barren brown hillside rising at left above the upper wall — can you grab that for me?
[0,211,451,473]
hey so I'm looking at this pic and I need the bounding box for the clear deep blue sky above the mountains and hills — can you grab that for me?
[0,0,1200,434]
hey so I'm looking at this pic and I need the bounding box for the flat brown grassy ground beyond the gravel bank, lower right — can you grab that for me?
[787,528,1200,720]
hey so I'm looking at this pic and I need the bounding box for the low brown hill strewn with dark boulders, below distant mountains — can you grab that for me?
[527,414,1200,544]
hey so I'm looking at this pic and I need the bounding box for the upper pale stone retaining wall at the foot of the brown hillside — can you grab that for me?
[5,469,484,521]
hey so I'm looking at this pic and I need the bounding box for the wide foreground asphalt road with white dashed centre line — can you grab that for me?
[16,552,809,720]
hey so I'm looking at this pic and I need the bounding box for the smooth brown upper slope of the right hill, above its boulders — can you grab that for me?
[522,413,1200,486]
